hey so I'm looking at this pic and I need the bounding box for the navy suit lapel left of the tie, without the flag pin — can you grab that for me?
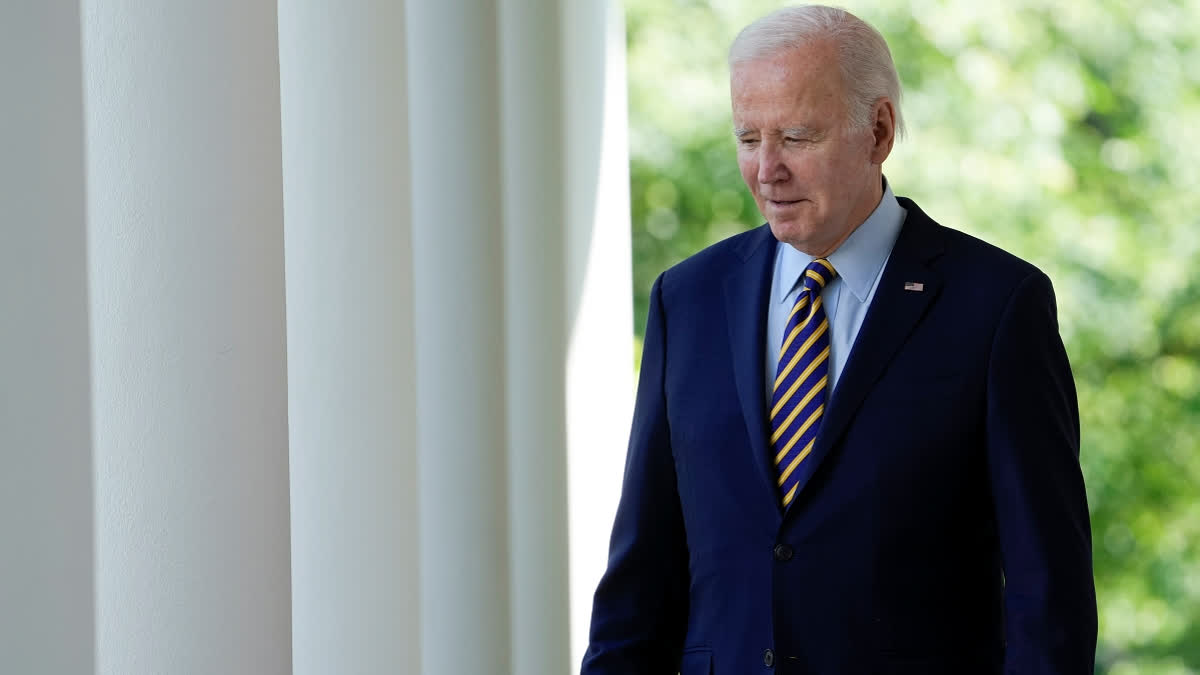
[725,226,781,514]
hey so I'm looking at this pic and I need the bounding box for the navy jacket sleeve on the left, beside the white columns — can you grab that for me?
[582,270,688,675]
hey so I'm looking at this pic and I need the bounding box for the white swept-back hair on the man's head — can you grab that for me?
[730,5,905,137]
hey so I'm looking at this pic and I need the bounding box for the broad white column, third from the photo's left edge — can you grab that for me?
[280,0,420,675]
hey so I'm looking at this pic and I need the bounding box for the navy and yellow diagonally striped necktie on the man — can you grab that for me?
[770,258,838,508]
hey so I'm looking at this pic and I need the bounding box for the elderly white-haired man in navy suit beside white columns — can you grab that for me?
[583,6,1096,675]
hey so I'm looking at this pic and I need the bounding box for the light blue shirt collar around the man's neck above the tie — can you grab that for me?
[775,179,907,303]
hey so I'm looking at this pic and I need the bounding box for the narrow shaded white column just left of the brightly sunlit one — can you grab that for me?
[499,0,572,675]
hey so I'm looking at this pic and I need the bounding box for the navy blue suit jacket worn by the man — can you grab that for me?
[583,198,1096,675]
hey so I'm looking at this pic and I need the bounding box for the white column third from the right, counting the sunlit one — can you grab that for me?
[406,5,511,675]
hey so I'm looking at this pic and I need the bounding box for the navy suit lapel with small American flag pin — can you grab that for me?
[793,197,942,506]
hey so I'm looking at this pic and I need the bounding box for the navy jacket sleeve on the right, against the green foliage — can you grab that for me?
[986,271,1097,675]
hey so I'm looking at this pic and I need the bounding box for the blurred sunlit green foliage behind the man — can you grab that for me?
[626,0,1200,675]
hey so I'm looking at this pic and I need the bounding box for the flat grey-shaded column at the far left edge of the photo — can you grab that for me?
[0,2,94,673]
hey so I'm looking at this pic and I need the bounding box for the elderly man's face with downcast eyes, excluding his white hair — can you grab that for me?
[731,40,890,256]
